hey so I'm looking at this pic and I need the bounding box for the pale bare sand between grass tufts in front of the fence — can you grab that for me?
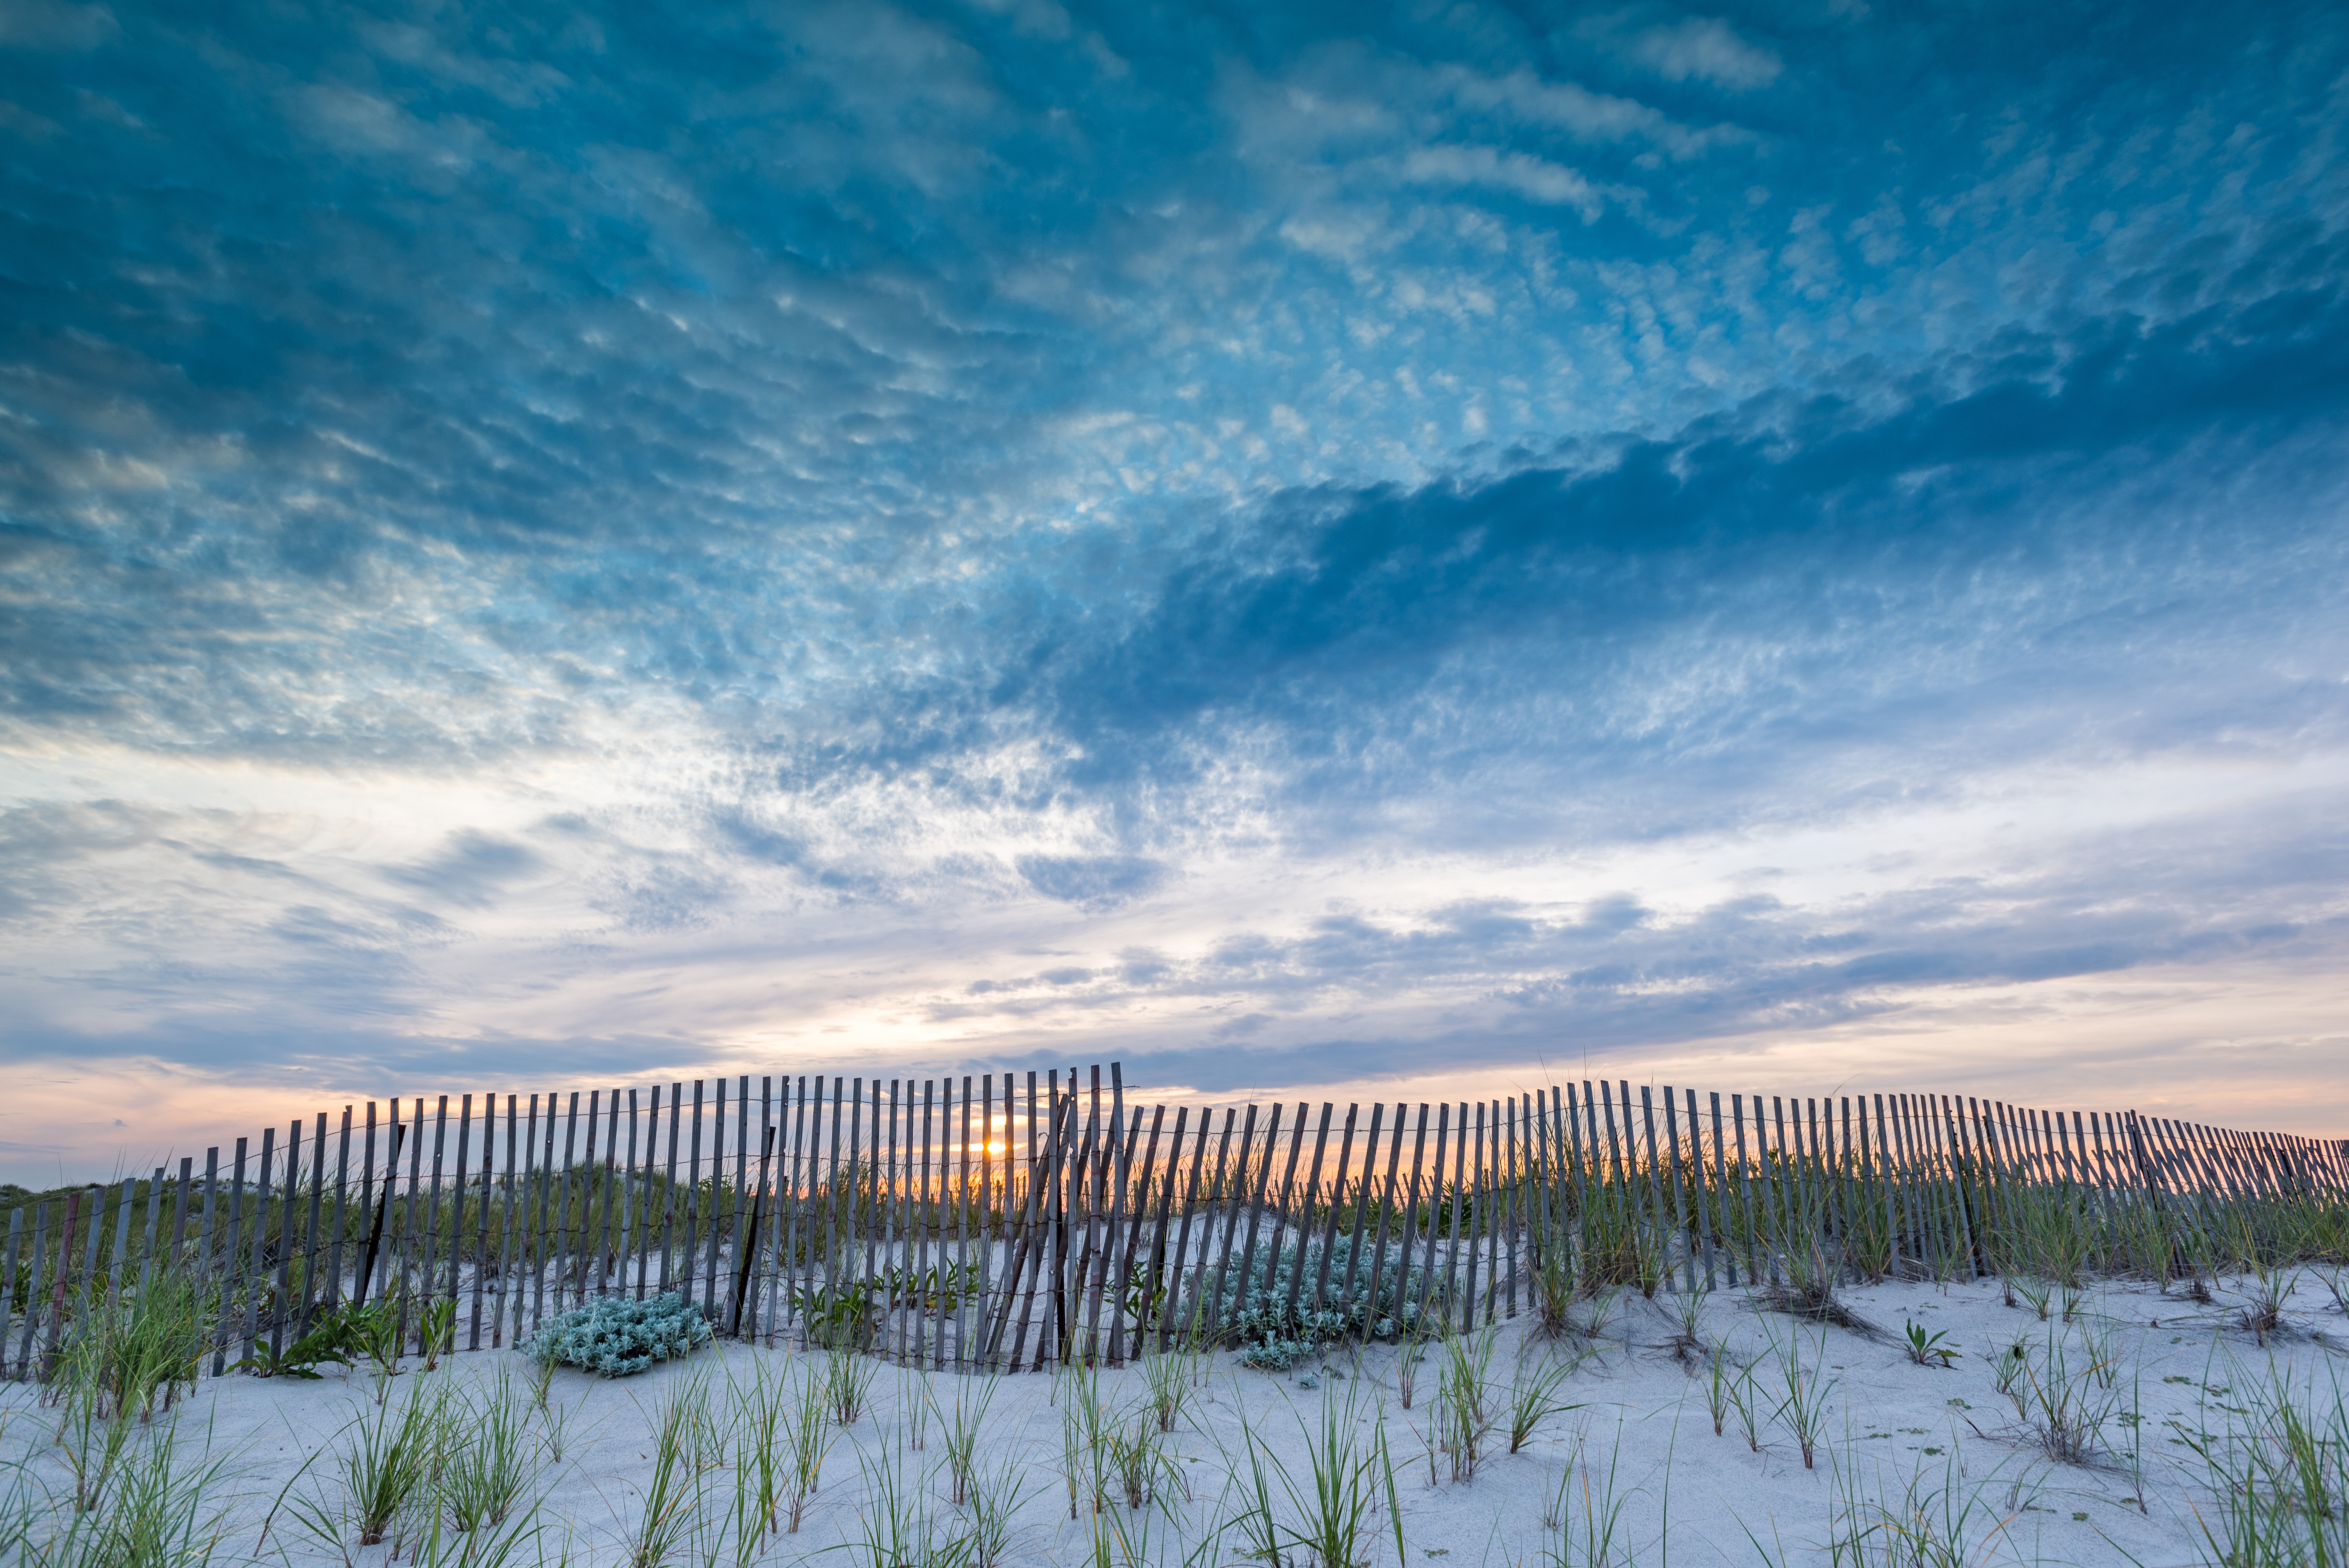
[0,1277,2349,1568]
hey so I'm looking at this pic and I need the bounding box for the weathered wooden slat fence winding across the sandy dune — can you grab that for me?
[0,1066,2349,1378]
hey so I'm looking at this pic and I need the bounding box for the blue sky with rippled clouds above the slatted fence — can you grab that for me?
[0,0,2349,1181]
